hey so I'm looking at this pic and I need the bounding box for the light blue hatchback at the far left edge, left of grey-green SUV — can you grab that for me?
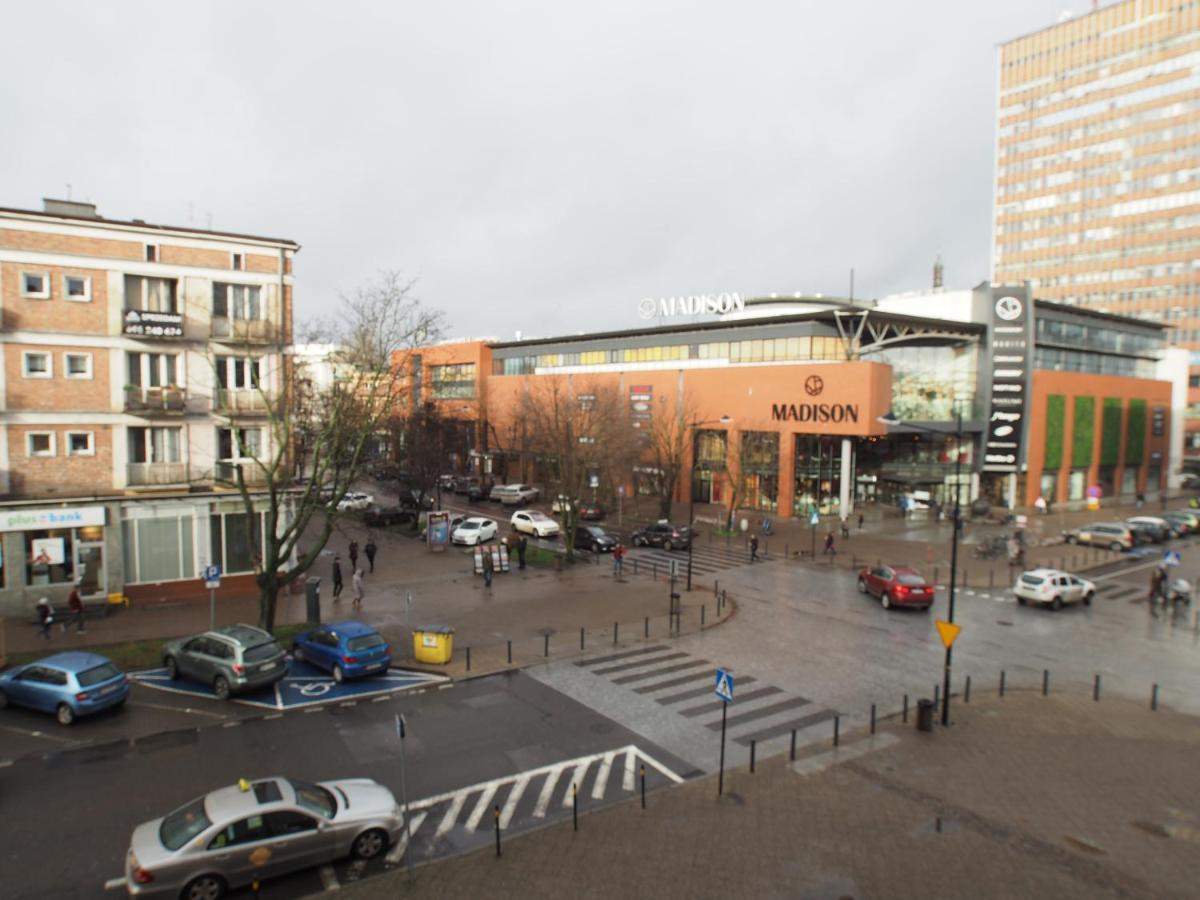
[0,650,130,725]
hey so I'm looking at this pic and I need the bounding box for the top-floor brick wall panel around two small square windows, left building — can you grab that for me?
[0,264,108,335]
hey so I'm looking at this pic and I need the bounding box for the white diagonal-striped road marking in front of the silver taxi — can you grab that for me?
[385,744,683,865]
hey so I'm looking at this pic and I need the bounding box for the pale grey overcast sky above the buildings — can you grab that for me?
[0,0,1091,338]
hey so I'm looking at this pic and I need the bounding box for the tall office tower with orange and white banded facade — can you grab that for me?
[992,0,1200,452]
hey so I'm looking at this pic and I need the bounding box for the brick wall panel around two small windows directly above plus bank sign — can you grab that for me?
[7,425,113,497]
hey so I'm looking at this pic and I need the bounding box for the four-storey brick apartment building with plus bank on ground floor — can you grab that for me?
[0,200,300,613]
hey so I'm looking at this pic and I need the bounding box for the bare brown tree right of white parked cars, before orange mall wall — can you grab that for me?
[517,376,629,559]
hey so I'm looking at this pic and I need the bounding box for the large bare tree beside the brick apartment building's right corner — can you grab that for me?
[215,271,442,629]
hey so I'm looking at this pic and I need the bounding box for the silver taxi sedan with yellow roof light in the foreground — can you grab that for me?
[125,778,403,900]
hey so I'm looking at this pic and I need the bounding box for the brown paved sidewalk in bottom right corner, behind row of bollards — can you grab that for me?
[341,692,1200,900]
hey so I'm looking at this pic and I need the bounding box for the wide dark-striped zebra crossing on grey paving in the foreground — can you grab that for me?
[574,644,838,755]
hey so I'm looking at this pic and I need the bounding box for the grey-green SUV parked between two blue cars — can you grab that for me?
[162,625,288,700]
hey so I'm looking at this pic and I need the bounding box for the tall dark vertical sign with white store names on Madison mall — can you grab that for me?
[983,287,1033,472]
